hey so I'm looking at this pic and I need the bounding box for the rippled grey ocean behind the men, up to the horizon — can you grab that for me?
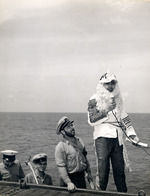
[0,113,150,195]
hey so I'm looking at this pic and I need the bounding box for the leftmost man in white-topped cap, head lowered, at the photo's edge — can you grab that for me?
[0,150,25,182]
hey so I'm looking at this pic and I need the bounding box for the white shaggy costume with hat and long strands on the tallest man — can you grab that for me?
[88,72,136,170]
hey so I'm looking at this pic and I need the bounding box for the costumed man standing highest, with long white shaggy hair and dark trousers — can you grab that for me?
[88,71,139,192]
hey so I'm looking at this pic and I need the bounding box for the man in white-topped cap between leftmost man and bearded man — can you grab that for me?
[25,153,53,185]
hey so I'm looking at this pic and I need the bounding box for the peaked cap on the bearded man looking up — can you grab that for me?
[56,116,74,135]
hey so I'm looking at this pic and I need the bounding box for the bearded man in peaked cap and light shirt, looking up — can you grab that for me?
[55,116,92,192]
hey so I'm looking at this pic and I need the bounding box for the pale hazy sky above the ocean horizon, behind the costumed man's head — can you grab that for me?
[0,0,150,113]
